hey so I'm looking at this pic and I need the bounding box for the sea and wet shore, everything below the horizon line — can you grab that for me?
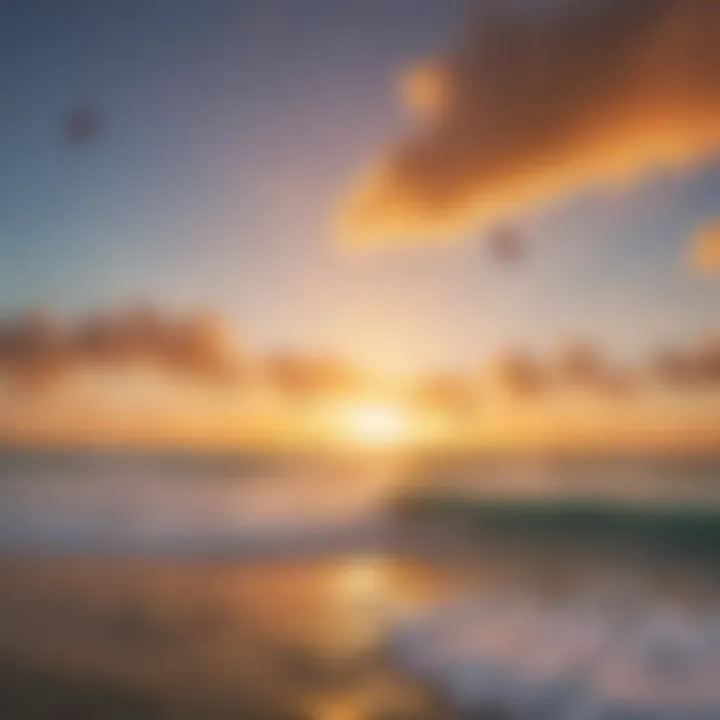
[0,449,720,720]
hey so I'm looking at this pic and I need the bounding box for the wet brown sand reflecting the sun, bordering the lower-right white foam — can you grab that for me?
[0,528,720,720]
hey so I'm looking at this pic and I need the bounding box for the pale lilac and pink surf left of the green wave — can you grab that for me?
[0,452,396,555]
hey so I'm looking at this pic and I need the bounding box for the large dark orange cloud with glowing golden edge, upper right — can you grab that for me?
[339,0,720,242]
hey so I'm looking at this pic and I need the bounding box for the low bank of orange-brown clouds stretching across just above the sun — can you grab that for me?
[0,306,720,404]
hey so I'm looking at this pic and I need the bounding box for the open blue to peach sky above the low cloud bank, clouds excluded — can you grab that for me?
[0,0,720,382]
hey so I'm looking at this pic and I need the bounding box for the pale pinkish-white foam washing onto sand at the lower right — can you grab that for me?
[390,595,720,720]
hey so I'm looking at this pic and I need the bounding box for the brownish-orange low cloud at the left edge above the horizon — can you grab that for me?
[0,306,241,390]
